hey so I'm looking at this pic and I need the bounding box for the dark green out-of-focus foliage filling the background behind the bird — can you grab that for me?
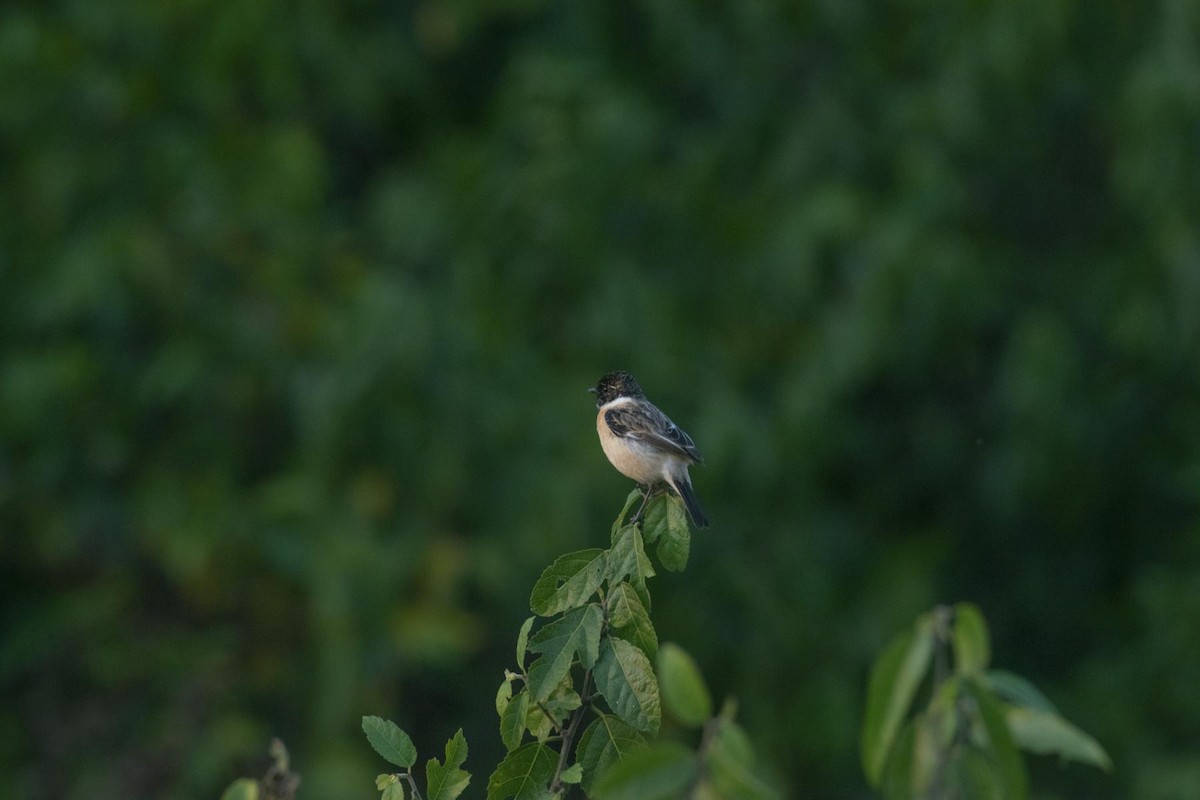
[0,0,1200,800]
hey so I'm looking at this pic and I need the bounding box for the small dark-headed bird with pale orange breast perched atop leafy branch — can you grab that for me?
[588,372,708,528]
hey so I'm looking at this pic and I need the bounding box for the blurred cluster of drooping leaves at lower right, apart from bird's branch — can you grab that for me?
[862,603,1111,800]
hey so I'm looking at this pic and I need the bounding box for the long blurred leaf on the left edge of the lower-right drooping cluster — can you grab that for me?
[863,614,934,787]
